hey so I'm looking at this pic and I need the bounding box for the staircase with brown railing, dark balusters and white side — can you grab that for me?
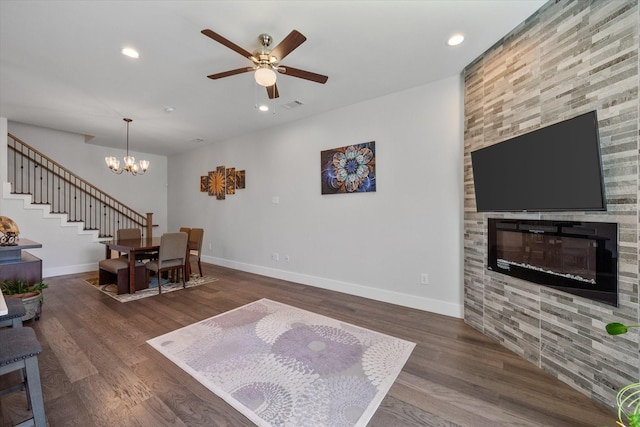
[0,133,153,280]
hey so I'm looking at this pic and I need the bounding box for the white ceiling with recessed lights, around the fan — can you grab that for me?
[0,0,545,155]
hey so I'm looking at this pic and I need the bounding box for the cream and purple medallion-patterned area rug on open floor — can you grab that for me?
[147,299,415,427]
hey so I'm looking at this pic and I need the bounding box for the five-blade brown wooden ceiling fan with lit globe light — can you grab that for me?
[201,29,329,99]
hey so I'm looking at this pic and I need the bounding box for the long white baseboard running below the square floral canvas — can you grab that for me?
[208,256,464,319]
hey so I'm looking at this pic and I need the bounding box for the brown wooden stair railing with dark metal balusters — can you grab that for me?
[7,134,153,237]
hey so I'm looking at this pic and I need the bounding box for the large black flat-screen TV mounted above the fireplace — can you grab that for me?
[471,111,606,212]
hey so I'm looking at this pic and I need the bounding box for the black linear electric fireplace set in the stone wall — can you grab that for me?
[487,218,618,307]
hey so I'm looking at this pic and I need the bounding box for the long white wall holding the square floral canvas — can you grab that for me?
[168,76,463,317]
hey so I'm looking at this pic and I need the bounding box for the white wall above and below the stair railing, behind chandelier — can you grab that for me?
[0,118,167,277]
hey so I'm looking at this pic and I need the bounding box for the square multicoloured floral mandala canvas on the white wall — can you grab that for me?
[320,141,376,194]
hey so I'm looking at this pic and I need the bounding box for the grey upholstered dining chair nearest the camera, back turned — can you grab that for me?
[145,232,188,294]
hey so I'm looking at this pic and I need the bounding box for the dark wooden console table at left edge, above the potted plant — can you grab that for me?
[0,238,42,284]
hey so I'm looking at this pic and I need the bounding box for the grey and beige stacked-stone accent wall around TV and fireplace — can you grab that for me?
[464,0,640,407]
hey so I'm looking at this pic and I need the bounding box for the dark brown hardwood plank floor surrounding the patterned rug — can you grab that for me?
[0,264,616,427]
